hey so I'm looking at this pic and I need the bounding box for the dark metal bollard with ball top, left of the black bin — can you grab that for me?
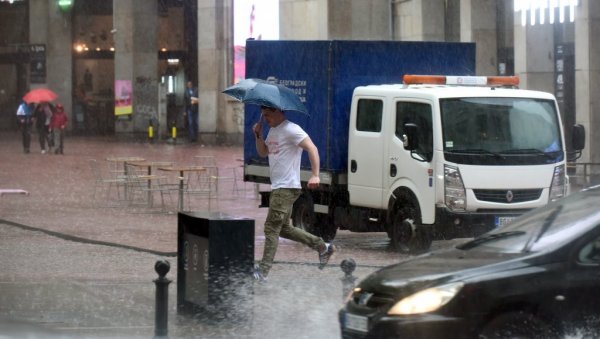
[154,259,171,338]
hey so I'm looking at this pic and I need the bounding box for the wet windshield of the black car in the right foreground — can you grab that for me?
[457,189,600,253]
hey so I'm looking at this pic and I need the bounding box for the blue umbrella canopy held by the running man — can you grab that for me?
[223,79,308,115]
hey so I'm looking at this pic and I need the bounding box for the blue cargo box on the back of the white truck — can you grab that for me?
[244,40,475,173]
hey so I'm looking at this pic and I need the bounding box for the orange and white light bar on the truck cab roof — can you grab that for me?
[403,74,519,86]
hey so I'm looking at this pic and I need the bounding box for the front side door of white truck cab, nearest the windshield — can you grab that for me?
[384,100,435,223]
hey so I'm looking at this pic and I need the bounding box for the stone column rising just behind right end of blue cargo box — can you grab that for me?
[460,0,498,75]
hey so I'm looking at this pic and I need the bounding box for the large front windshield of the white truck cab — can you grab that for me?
[440,97,564,165]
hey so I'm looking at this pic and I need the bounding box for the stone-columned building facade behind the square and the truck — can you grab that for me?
[0,0,600,162]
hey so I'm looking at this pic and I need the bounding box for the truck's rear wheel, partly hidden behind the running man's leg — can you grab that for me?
[292,193,337,242]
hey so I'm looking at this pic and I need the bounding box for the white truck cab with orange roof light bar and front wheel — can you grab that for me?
[347,75,585,252]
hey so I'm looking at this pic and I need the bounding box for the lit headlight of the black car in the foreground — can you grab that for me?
[388,282,464,315]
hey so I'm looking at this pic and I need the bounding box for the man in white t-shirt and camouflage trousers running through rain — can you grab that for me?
[254,106,336,282]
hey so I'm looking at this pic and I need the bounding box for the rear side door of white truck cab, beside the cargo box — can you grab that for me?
[348,97,387,208]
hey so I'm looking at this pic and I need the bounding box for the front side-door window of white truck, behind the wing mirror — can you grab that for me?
[396,102,433,161]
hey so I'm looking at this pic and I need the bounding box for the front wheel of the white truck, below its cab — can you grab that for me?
[388,198,432,254]
